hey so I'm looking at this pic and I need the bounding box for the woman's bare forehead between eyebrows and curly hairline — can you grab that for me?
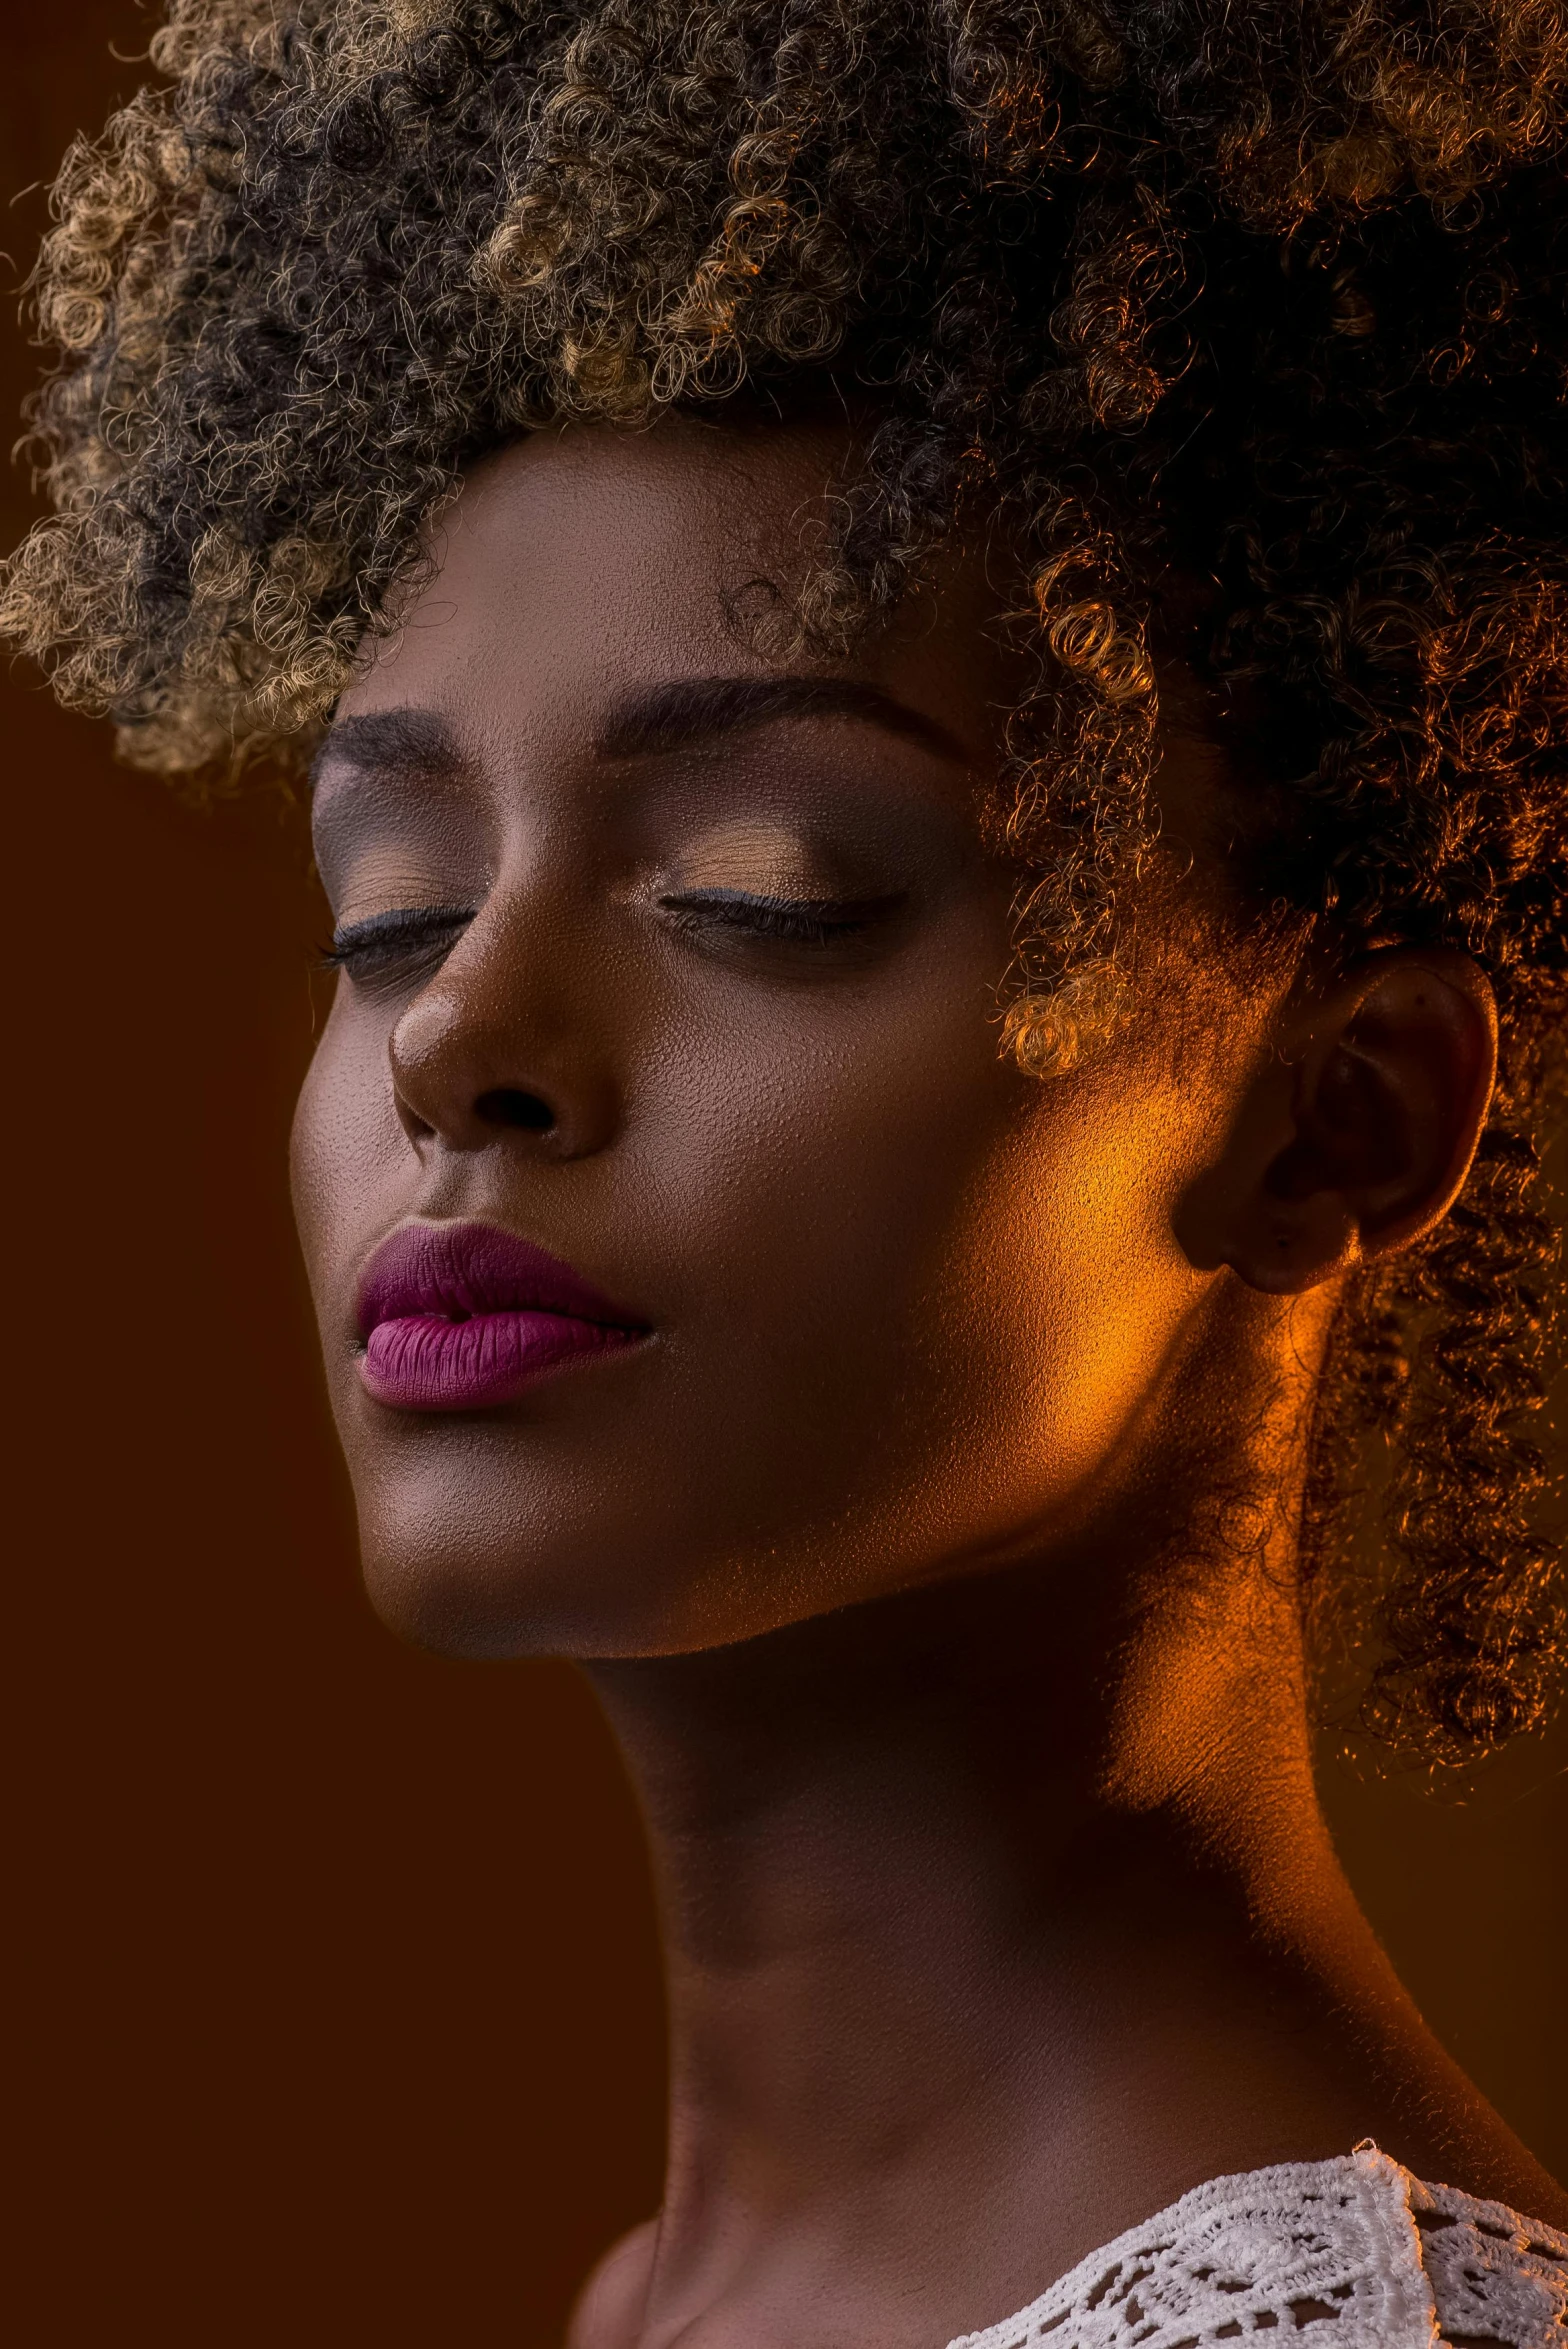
[340,418,1016,752]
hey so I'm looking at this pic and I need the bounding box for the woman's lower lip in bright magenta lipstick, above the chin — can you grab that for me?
[359,1313,636,1412]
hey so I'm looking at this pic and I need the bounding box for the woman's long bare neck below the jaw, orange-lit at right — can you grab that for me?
[594,1503,1445,2344]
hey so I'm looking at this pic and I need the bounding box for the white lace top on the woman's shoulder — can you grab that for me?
[948,2145,1568,2349]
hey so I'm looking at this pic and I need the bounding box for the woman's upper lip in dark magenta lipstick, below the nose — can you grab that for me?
[357,1221,648,1339]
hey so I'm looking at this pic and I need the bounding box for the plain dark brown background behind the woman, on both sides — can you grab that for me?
[0,0,1568,2349]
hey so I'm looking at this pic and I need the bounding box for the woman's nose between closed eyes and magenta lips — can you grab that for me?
[387,914,620,1158]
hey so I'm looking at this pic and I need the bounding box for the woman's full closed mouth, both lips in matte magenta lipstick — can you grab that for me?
[359,1224,648,1412]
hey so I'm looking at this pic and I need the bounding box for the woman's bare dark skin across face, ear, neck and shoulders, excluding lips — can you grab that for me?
[296,423,1566,2349]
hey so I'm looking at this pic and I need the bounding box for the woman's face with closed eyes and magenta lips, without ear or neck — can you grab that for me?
[293,423,1246,1656]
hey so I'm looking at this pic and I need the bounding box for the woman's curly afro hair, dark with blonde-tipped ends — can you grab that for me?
[0,0,1568,1759]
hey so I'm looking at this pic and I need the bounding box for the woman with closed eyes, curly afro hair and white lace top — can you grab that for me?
[5,0,1568,2349]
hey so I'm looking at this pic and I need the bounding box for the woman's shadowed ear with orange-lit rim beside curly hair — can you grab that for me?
[1178,947,1498,1297]
